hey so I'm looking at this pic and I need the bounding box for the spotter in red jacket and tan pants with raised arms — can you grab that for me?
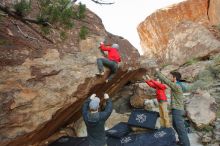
[143,75,171,128]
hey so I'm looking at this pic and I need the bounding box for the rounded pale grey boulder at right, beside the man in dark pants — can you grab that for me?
[186,91,216,128]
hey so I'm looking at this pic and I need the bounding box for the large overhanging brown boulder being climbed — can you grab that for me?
[0,4,142,146]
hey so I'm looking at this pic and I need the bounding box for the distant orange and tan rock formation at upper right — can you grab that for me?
[138,0,220,65]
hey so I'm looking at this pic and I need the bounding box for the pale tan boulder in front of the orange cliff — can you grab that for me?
[163,21,220,65]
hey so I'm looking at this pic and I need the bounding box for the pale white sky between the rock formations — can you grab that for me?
[79,0,183,54]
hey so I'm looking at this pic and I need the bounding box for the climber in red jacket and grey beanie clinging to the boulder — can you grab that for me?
[97,42,121,82]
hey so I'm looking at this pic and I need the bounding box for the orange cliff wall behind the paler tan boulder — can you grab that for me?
[137,0,208,60]
